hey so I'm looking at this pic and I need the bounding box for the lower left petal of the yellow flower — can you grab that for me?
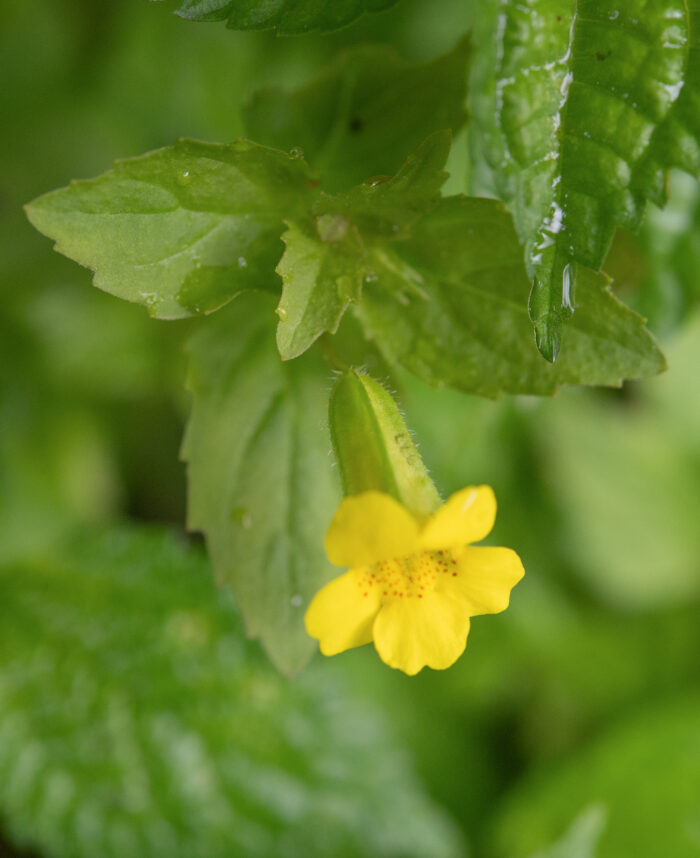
[304,570,380,655]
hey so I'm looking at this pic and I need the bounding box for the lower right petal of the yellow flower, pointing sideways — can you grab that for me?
[438,546,525,617]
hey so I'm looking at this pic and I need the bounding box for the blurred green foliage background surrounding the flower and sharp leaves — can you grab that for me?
[0,0,700,858]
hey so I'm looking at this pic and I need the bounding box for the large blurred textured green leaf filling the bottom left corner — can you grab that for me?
[0,528,464,858]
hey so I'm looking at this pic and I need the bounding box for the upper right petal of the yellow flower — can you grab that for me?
[419,486,496,551]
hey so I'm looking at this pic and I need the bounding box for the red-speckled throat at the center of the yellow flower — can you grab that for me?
[358,551,457,599]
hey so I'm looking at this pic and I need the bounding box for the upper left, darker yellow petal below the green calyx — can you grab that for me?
[326,491,418,567]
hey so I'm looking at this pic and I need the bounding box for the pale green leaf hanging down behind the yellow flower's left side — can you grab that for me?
[183,293,338,673]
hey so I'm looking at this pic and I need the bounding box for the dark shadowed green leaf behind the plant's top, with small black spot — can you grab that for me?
[244,41,470,191]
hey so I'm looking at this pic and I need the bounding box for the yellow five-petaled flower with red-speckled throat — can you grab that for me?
[306,486,524,675]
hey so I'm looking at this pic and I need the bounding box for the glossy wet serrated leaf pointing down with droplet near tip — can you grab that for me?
[474,0,698,360]
